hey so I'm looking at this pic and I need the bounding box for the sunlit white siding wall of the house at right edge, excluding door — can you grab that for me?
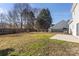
[69,4,79,36]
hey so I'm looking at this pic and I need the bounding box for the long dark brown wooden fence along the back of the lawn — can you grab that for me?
[0,28,48,35]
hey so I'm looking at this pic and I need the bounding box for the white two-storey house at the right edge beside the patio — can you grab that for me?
[69,3,79,36]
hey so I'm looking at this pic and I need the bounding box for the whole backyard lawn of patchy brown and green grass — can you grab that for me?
[0,32,79,56]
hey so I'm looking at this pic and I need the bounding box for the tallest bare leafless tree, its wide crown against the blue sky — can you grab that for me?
[14,3,31,29]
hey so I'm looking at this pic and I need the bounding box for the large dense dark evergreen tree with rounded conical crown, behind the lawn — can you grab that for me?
[36,9,52,31]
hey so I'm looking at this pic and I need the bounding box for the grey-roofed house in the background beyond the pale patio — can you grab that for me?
[49,20,68,32]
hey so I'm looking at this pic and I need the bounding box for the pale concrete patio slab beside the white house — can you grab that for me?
[50,34,79,43]
